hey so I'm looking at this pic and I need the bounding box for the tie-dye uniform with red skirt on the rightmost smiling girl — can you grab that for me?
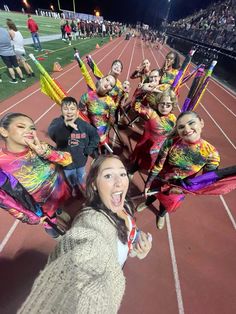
[146,138,220,212]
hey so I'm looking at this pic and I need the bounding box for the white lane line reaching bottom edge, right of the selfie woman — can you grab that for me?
[166,214,184,314]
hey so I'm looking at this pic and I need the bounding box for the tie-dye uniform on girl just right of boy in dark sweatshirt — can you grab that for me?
[80,91,116,142]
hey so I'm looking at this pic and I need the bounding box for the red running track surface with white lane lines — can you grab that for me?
[0,39,236,314]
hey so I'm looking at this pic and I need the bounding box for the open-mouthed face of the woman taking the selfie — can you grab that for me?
[95,158,129,213]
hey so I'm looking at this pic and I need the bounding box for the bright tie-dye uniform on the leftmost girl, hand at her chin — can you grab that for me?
[0,145,72,223]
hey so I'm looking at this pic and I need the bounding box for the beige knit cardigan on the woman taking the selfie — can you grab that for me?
[18,208,125,314]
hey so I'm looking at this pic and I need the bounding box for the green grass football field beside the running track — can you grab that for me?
[0,12,109,101]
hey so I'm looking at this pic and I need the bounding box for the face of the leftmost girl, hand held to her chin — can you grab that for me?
[0,116,35,153]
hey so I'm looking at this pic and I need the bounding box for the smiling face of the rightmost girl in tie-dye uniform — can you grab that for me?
[176,113,204,143]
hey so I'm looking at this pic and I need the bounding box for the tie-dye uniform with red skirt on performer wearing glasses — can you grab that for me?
[131,104,176,170]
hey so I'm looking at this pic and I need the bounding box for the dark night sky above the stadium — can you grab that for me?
[3,0,220,25]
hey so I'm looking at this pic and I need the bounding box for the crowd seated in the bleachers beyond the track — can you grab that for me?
[167,0,236,51]
